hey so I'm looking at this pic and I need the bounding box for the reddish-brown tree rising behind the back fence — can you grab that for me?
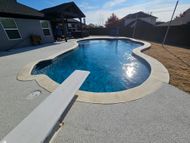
[105,13,119,28]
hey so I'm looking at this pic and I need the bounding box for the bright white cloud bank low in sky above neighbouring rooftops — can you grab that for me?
[85,0,190,25]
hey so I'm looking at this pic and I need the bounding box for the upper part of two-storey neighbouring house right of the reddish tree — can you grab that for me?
[120,12,157,27]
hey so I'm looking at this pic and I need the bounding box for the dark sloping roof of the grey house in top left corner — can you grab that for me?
[0,0,44,18]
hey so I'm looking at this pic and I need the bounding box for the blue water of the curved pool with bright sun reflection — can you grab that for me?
[32,40,150,92]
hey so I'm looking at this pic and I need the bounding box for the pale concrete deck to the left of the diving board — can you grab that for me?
[0,42,75,140]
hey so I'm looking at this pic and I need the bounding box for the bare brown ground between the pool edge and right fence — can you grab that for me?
[144,43,190,93]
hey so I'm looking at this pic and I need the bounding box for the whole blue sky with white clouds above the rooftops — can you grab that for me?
[18,0,190,25]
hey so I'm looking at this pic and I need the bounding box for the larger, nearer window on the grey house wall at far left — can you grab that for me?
[0,18,21,40]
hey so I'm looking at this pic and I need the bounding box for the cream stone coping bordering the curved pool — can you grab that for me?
[17,36,170,104]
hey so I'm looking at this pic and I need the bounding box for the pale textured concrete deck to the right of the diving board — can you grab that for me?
[52,84,190,143]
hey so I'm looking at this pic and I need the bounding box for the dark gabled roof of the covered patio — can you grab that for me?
[41,2,85,18]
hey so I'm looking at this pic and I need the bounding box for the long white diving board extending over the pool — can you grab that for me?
[1,70,89,143]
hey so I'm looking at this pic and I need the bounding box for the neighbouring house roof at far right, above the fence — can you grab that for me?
[158,8,190,26]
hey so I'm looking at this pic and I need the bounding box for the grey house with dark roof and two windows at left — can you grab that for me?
[0,0,54,51]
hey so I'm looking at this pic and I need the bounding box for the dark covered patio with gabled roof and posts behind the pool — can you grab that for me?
[41,2,85,39]
